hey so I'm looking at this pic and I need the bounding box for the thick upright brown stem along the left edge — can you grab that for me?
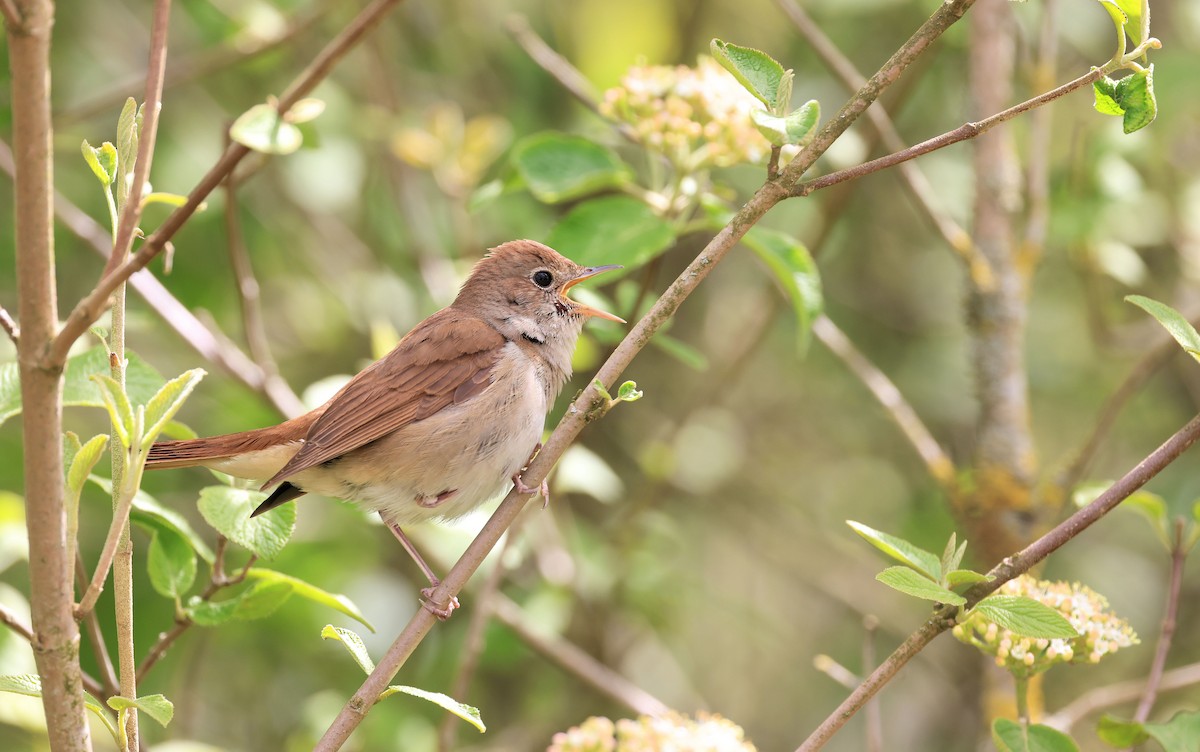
[6,0,91,750]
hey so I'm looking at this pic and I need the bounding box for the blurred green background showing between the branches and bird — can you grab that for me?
[0,0,1200,752]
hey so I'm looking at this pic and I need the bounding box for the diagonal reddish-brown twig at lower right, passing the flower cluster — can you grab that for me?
[797,415,1200,752]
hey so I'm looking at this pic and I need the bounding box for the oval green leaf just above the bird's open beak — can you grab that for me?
[546,195,674,282]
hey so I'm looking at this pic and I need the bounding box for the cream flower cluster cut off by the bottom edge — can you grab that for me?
[546,712,755,752]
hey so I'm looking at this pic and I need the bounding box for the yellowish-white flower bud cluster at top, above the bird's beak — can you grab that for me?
[600,55,770,173]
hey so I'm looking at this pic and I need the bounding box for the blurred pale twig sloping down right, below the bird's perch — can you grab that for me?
[492,592,671,716]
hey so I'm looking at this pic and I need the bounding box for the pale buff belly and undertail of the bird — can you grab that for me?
[210,345,548,525]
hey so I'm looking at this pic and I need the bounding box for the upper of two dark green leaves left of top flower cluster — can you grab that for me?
[509,132,632,202]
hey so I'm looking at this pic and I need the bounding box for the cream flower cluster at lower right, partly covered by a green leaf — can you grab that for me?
[954,574,1139,678]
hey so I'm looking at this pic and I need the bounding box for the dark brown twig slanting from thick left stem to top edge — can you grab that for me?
[43,0,401,367]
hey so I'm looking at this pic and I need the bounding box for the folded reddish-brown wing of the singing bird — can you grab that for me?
[263,308,504,488]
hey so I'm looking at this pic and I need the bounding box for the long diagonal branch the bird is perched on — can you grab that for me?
[316,0,974,752]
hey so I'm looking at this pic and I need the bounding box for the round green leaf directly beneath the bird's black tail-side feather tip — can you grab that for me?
[198,486,296,559]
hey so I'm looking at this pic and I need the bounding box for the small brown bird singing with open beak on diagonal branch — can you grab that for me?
[146,240,625,619]
